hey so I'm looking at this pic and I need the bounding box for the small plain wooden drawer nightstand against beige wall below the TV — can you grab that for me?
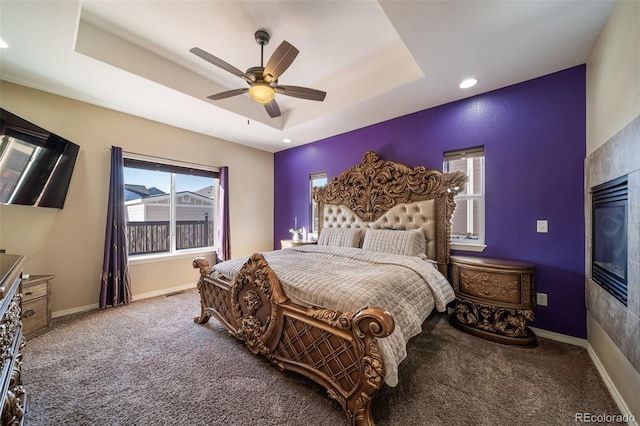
[22,275,54,339]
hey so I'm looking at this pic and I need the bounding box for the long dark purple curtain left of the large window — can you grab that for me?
[100,146,131,309]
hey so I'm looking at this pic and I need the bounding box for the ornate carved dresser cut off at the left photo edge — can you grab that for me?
[0,254,27,426]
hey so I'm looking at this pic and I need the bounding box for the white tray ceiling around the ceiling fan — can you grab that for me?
[0,0,613,152]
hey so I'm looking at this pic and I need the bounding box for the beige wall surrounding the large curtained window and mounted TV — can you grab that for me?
[0,81,273,314]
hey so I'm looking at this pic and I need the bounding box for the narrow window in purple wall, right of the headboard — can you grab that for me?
[444,147,485,251]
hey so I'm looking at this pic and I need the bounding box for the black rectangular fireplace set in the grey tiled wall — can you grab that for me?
[591,176,629,306]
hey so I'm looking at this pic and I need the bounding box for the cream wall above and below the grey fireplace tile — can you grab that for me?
[587,1,640,419]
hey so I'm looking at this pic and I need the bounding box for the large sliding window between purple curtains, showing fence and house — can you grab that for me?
[124,158,219,256]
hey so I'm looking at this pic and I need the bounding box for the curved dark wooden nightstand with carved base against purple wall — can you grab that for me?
[450,256,537,346]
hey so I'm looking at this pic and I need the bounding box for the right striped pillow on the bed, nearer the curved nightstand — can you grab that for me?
[362,229,427,257]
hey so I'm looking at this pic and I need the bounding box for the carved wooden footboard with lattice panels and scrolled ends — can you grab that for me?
[193,253,394,426]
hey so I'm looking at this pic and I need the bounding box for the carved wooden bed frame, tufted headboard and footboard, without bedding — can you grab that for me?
[193,152,465,425]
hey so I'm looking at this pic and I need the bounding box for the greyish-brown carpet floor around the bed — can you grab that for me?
[23,289,619,426]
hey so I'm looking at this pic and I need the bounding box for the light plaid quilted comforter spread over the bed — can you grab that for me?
[215,245,455,386]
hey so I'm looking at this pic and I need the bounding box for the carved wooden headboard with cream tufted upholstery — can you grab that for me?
[313,151,466,274]
